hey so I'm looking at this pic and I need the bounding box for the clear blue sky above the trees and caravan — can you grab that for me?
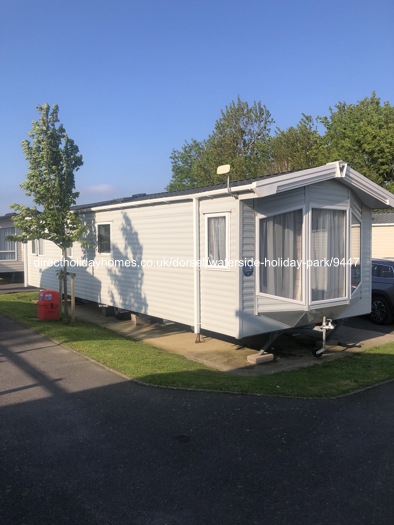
[0,0,394,215]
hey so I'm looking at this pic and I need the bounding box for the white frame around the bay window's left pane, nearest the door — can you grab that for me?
[256,205,308,305]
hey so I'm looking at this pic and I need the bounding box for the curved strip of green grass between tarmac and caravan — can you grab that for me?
[0,292,394,397]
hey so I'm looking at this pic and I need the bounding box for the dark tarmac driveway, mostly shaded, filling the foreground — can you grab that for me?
[0,316,394,525]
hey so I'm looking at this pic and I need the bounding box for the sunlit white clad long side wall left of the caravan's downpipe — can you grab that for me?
[29,202,193,325]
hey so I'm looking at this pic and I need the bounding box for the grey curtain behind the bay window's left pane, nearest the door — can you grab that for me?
[260,210,302,301]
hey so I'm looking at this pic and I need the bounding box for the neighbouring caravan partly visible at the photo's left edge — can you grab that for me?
[0,213,24,282]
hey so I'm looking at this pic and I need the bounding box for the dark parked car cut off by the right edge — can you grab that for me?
[369,259,394,324]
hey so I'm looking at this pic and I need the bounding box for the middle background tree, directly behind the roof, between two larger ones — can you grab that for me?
[270,114,322,173]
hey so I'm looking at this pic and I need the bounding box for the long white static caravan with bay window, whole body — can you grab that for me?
[26,161,394,339]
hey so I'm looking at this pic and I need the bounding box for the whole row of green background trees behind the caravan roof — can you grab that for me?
[167,93,394,191]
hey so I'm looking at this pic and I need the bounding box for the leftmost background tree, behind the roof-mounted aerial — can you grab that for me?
[167,97,274,190]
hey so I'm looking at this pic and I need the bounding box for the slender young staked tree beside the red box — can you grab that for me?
[11,104,84,322]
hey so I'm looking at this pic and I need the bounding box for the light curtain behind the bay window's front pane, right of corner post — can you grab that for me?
[310,208,346,301]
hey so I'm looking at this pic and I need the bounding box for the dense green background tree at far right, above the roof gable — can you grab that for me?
[319,93,394,190]
